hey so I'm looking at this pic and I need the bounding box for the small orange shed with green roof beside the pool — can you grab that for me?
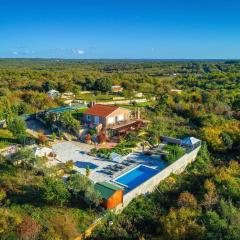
[95,182,123,209]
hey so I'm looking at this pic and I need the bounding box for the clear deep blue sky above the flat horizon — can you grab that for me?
[0,0,240,59]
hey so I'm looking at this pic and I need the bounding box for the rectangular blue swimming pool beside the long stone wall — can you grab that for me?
[112,165,159,189]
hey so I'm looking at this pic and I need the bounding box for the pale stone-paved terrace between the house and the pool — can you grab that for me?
[53,142,166,182]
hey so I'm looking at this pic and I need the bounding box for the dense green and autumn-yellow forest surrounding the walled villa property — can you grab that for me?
[0,59,240,240]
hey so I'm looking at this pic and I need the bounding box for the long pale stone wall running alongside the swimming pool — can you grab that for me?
[116,146,201,211]
